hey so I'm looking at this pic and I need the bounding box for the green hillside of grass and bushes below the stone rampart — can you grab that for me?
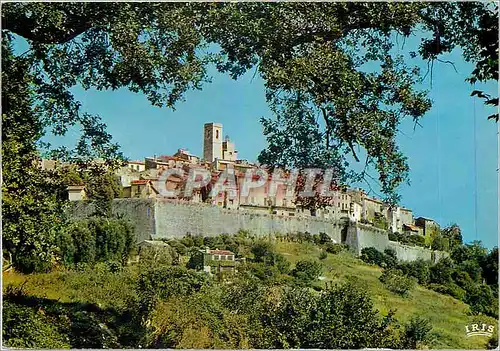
[3,234,497,349]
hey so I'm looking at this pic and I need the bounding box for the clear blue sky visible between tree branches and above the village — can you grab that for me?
[16,33,498,247]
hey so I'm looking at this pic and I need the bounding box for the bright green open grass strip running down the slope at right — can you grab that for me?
[277,242,498,349]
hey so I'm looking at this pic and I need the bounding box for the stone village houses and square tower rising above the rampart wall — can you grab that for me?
[51,123,439,242]
